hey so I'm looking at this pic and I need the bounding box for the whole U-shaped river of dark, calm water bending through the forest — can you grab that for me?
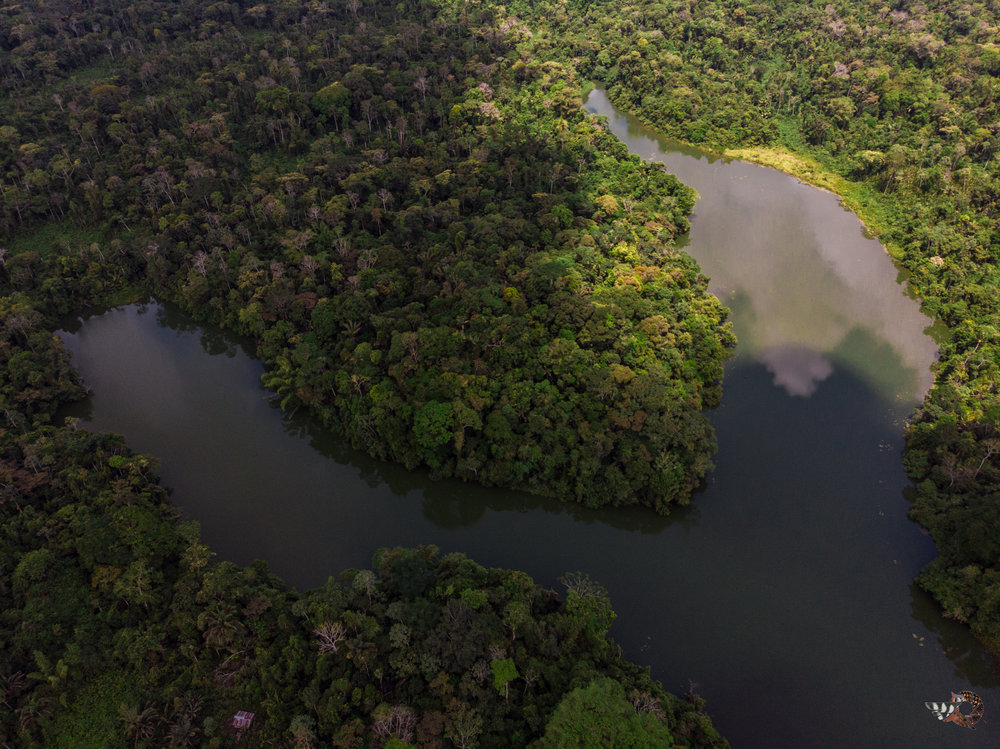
[61,91,1000,749]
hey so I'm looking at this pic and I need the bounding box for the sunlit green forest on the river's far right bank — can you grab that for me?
[511,0,1000,652]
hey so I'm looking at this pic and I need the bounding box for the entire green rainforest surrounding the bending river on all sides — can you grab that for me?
[0,0,1000,747]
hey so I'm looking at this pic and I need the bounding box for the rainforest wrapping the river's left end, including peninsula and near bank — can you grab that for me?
[0,0,732,749]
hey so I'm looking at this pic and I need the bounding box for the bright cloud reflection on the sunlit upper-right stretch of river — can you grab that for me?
[587,90,937,403]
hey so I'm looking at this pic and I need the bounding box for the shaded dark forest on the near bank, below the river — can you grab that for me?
[0,418,726,749]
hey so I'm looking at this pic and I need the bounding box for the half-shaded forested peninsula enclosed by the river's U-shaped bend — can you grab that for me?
[0,2,732,512]
